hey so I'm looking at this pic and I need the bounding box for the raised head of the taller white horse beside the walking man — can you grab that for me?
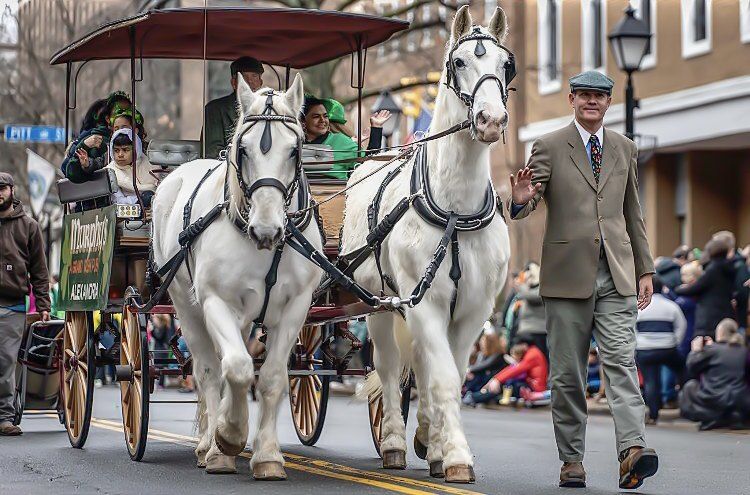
[445,5,515,144]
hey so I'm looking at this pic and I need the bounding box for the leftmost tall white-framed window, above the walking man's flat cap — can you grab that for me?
[537,0,562,95]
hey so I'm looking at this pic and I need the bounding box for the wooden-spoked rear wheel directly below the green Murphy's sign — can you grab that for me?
[60,311,96,449]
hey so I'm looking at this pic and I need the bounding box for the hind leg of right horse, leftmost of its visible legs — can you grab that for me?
[367,313,406,469]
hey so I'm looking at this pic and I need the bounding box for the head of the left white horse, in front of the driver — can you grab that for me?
[230,74,304,249]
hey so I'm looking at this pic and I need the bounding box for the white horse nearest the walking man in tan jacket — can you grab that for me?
[342,6,511,483]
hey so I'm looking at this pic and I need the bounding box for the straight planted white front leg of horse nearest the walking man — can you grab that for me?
[407,306,474,483]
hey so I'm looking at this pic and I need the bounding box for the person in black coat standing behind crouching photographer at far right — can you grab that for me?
[674,239,735,339]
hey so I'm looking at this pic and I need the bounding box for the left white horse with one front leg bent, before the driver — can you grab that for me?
[153,75,322,479]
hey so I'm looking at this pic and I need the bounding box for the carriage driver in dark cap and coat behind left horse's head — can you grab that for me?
[204,57,263,158]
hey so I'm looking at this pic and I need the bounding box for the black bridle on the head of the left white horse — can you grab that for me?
[235,90,302,209]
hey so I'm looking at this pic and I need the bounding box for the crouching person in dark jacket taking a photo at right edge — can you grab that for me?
[680,319,750,430]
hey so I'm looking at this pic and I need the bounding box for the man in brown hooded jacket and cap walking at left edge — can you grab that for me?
[0,172,50,436]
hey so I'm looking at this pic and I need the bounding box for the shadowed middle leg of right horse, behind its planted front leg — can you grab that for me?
[412,348,443,478]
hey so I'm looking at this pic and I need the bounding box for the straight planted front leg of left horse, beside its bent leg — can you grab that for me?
[250,297,308,481]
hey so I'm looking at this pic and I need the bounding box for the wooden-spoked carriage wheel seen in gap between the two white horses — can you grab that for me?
[289,326,330,446]
